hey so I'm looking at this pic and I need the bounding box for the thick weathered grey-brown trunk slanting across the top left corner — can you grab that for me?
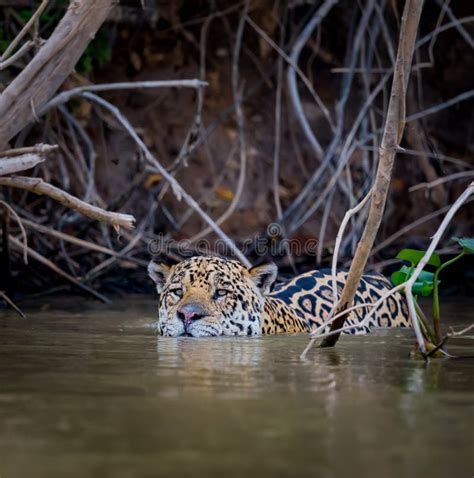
[0,0,116,148]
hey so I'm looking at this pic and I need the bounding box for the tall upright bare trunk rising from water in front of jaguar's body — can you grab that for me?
[321,0,423,347]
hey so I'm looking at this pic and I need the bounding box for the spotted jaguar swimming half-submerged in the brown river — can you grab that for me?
[148,256,410,337]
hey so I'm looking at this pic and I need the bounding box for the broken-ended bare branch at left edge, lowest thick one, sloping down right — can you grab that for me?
[0,176,135,229]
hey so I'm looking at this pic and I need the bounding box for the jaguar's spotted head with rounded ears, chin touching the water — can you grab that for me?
[148,256,277,337]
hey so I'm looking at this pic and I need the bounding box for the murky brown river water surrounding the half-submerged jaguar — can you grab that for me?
[0,299,474,478]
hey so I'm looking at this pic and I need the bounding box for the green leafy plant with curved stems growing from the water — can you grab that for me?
[391,237,474,350]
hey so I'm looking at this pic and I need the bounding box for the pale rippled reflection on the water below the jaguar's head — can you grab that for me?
[157,337,336,398]
